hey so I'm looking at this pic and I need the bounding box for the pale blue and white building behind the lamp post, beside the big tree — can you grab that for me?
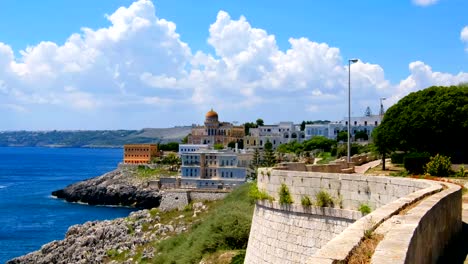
[305,115,383,140]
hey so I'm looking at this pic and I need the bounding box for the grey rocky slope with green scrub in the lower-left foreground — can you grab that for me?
[7,203,207,264]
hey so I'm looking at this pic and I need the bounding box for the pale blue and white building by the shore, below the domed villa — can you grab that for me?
[180,149,252,189]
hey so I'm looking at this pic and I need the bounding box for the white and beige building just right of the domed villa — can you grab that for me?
[244,122,305,149]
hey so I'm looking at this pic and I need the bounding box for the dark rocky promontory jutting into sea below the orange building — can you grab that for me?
[52,169,162,209]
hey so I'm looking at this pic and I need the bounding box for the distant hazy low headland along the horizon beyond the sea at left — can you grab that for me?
[0,126,191,147]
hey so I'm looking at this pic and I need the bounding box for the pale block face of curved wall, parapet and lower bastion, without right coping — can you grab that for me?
[245,169,431,263]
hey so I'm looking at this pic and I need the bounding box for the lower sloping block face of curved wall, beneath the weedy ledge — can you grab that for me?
[245,201,362,263]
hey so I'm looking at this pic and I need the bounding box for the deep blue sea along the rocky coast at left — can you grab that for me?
[0,147,132,263]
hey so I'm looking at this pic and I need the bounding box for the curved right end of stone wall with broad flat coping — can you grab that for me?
[372,183,462,264]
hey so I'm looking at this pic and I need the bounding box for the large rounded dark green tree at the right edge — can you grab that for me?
[374,85,468,162]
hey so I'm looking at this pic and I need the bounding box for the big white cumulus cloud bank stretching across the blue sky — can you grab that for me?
[0,0,468,127]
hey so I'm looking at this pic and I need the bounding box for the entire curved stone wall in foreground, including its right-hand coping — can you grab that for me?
[245,169,461,264]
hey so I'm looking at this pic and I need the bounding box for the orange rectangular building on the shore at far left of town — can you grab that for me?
[124,144,159,164]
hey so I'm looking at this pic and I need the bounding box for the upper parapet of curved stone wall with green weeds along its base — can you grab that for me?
[257,168,428,210]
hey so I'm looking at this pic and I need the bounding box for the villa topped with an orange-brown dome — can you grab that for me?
[188,109,245,146]
